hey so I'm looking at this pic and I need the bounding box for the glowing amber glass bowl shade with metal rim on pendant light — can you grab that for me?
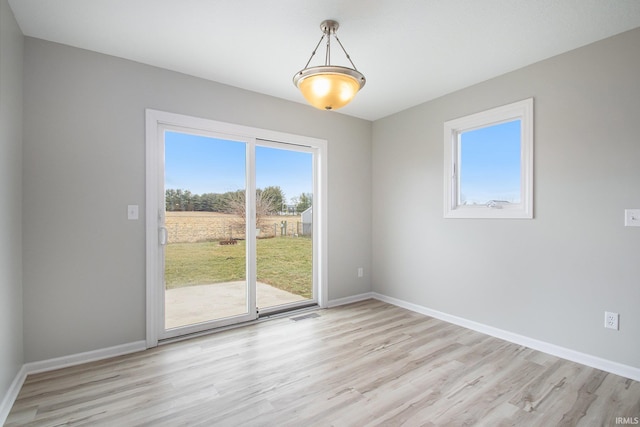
[293,66,366,110]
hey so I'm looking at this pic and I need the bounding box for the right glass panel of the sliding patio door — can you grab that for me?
[255,141,317,314]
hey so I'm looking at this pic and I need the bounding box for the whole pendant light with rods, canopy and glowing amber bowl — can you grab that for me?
[293,19,366,110]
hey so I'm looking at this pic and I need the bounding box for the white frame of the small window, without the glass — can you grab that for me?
[444,98,533,219]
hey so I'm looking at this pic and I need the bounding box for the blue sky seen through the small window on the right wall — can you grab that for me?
[459,120,520,204]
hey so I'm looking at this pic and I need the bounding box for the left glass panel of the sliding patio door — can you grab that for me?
[163,130,255,335]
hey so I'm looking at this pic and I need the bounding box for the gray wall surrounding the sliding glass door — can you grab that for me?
[23,38,372,362]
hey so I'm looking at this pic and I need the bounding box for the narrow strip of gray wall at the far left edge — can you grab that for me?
[0,0,24,401]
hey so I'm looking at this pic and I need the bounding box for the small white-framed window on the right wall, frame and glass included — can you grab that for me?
[444,98,533,218]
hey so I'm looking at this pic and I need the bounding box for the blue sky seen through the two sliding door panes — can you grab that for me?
[165,132,313,203]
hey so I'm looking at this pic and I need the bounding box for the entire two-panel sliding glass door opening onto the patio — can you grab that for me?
[148,125,320,340]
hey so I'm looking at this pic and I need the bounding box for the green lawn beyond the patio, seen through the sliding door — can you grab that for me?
[165,237,312,298]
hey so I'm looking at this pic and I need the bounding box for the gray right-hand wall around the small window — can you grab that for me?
[372,29,640,368]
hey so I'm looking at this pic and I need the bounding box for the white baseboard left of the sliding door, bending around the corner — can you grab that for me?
[0,341,147,425]
